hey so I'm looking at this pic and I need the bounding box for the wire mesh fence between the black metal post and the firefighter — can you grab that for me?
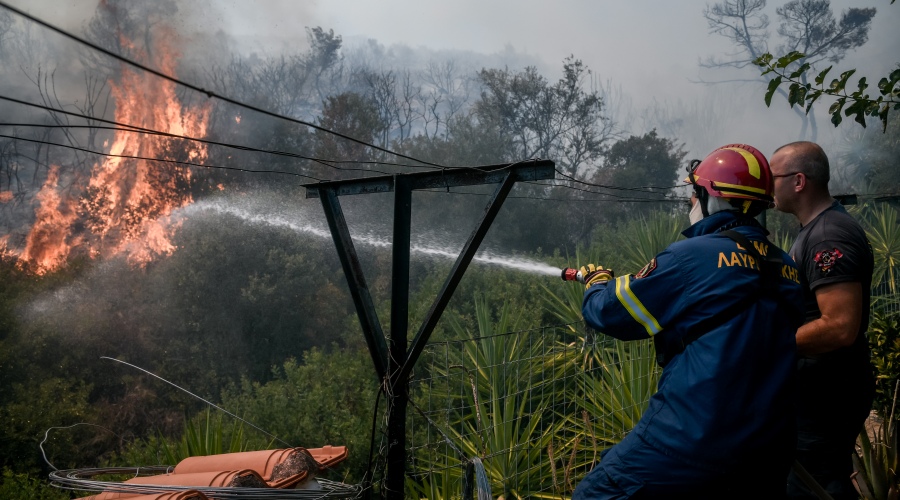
[407,324,659,498]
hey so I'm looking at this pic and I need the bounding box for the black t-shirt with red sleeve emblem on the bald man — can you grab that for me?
[790,201,874,365]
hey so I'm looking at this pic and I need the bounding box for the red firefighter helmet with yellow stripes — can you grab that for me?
[684,144,775,202]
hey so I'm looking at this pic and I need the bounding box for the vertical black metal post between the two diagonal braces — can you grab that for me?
[385,176,412,499]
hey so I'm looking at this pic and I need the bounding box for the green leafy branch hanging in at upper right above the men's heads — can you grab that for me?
[753,51,900,130]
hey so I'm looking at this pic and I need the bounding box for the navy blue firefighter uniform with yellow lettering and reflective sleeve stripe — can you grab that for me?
[573,211,803,498]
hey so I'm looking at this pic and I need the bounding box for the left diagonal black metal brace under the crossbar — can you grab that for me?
[321,189,388,380]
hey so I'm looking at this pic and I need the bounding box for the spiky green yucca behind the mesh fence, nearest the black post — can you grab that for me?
[407,297,573,499]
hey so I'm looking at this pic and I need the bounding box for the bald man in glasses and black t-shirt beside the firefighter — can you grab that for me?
[770,142,875,500]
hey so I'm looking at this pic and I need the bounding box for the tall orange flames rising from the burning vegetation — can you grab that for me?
[13,25,210,273]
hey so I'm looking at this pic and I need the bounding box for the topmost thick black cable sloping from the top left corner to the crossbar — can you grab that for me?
[0,1,443,167]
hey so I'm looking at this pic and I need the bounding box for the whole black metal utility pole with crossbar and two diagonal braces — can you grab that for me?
[303,160,556,499]
